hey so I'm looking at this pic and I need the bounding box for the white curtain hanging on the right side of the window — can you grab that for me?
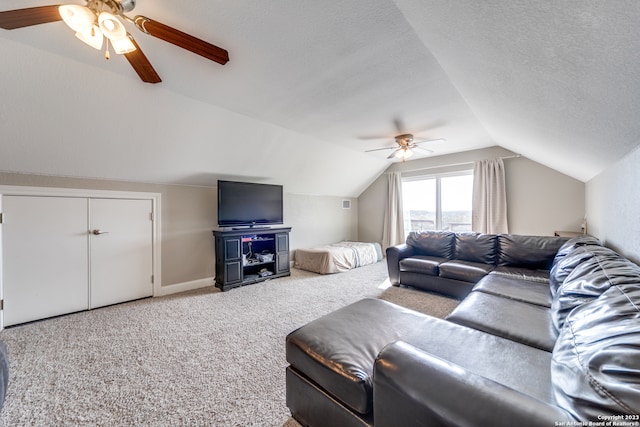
[471,158,509,234]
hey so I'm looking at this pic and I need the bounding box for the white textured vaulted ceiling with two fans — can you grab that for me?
[0,0,640,196]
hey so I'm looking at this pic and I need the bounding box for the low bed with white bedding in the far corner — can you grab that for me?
[295,242,382,274]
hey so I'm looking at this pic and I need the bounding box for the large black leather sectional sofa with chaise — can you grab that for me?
[286,232,640,427]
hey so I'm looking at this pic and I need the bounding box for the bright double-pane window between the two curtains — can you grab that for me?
[402,171,473,235]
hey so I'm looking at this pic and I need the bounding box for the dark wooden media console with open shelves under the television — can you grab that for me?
[213,227,291,291]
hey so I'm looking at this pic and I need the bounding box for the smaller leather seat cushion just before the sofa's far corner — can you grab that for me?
[473,274,551,308]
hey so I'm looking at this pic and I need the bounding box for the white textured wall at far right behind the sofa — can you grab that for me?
[586,146,640,263]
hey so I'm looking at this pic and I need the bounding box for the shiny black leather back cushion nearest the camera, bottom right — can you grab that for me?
[551,284,640,421]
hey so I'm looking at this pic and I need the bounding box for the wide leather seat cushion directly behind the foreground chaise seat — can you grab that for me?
[447,291,557,351]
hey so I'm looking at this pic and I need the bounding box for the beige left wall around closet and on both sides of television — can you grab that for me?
[0,172,358,293]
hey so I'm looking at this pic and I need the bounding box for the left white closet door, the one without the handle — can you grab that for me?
[2,196,89,326]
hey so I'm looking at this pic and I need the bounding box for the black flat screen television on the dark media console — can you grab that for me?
[218,181,284,227]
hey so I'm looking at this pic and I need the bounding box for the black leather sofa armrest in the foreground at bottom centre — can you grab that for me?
[373,341,575,427]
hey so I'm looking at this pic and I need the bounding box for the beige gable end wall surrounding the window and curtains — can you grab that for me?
[358,147,585,242]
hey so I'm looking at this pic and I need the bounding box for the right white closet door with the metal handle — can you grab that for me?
[89,199,153,308]
